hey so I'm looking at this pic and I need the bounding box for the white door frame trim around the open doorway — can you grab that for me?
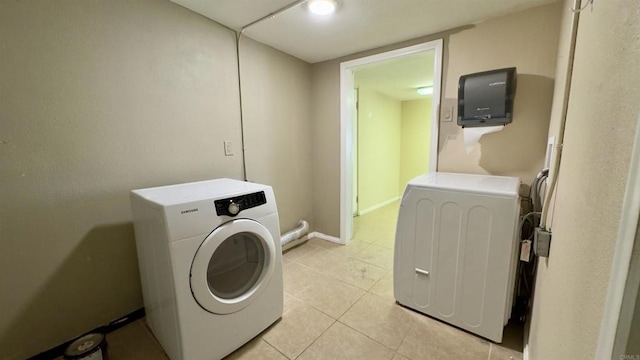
[340,39,443,244]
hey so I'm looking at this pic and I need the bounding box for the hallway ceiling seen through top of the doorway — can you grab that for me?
[354,50,435,101]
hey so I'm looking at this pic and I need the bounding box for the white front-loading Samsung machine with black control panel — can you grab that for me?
[131,179,284,360]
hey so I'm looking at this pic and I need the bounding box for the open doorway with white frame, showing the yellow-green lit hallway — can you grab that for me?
[340,39,442,244]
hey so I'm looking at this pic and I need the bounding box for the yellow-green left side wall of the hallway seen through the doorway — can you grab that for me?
[356,87,402,213]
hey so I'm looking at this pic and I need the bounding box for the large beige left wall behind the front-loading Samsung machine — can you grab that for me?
[0,0,312,359]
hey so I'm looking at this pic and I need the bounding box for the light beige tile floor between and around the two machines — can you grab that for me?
[100,202,523,360]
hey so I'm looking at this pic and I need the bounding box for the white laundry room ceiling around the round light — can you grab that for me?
[171,0,556,63]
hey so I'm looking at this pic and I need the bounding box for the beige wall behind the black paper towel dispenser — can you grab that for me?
[438,4,560,187]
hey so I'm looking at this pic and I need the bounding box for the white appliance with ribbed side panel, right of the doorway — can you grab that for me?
[393,173,520,342]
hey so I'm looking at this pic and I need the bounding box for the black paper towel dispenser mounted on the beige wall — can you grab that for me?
[458,67,516,127]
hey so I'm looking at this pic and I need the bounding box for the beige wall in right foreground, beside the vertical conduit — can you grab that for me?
[529,0,640,360]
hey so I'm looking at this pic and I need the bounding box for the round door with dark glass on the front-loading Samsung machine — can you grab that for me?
[190,219,280,314]
